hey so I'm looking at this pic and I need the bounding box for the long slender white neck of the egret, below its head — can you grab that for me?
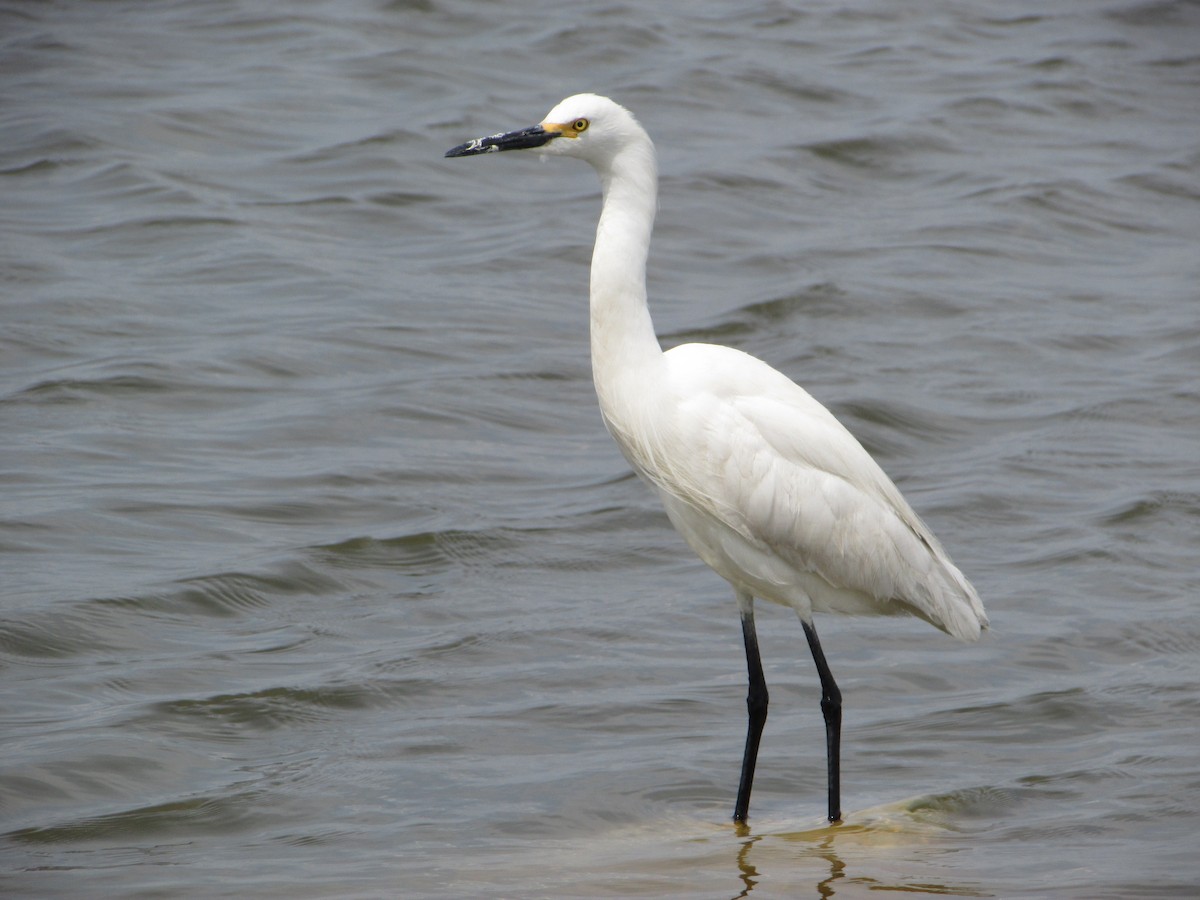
[592,132,662,427]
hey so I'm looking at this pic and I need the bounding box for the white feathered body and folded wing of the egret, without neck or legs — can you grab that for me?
[610,344,988,640]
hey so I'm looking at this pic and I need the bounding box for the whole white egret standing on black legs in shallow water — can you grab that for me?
[446,94,988,823]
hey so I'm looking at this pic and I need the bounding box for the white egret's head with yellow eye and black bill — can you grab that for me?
[446,94,646,167]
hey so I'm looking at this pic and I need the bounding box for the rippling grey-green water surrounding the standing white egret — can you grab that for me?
[0,0,1200,898]
